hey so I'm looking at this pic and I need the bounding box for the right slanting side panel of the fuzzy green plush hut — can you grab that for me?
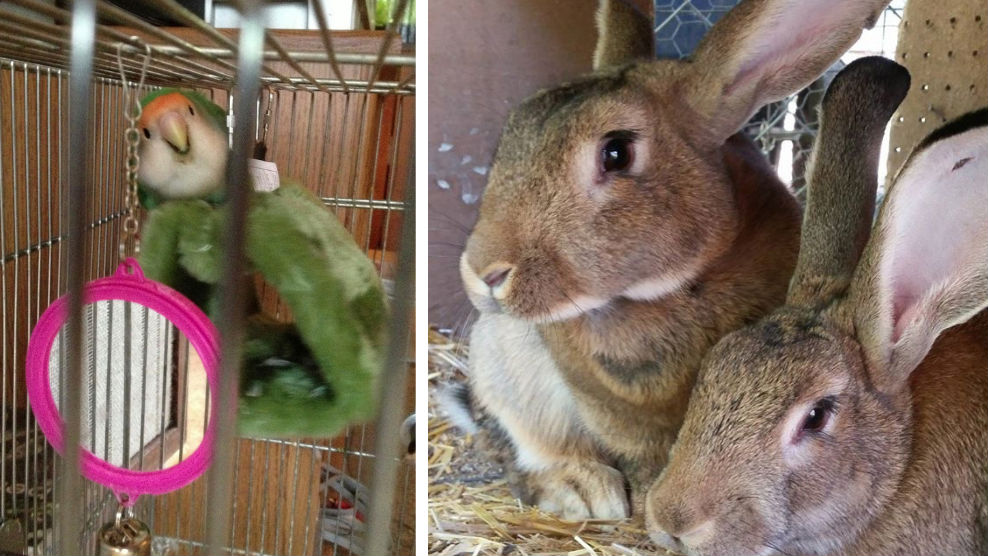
[241,185,387,430]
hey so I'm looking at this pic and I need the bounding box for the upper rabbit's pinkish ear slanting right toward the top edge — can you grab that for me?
[682,0,889,144]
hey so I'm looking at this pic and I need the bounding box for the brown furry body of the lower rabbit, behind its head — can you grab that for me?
[846,312,988,554]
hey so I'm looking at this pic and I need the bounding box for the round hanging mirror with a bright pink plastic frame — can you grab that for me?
[26,259,219,497]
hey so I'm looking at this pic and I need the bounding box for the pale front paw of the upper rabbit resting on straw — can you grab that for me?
[528,462,630,521]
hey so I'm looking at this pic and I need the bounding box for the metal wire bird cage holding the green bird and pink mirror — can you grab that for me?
[0,0,415,554]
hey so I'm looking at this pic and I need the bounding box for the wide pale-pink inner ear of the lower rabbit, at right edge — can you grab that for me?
[849,109,988,390]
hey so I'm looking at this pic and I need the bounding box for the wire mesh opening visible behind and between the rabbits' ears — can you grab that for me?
[655,0,906,197]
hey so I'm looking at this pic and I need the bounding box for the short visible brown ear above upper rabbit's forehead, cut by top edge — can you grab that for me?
[593,0,655,70]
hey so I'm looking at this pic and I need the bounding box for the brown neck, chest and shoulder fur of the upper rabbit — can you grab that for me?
[540,132,799,493]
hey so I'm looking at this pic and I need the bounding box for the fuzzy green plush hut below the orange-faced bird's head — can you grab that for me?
[141,180,388,437]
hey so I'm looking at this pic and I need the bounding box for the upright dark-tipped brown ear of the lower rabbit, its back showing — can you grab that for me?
[786,56,909,308]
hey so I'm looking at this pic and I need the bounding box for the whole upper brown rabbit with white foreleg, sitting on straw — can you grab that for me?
[460,0,887,518]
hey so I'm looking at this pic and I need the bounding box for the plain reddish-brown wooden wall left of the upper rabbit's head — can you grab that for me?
[428,0,597,327]
